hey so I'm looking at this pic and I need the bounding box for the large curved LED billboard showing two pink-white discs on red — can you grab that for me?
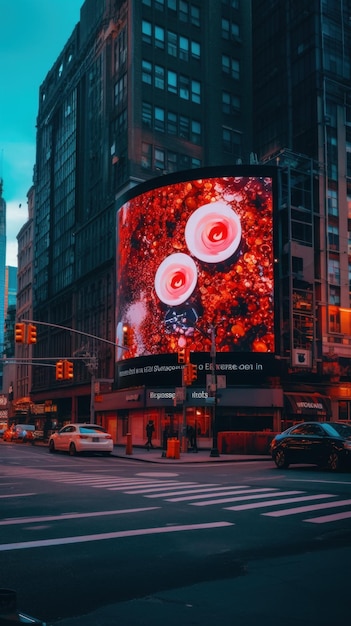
[116,166,275,386]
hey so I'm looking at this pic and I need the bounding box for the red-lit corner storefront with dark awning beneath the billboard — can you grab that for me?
[95,387,283,448]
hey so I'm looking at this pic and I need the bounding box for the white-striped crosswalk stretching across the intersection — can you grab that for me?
[0,466,351,524]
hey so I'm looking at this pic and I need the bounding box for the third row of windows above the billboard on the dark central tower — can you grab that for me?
[142,60,201,104]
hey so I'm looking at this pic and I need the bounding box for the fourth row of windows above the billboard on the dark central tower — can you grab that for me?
[142,20,201,61]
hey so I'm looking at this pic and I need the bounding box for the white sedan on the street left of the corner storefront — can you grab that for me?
[49,424,113,456]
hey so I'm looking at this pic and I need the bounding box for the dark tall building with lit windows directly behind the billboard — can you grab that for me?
[32,0,258,438]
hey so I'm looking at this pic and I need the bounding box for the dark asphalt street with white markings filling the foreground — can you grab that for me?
[0,442,351,626]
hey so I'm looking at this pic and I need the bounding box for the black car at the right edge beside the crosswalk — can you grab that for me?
[270,422,351,471]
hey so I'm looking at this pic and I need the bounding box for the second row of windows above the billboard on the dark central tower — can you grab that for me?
[142,102,202,145]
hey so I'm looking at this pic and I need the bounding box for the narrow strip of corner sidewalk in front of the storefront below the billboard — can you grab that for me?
[112,446,271,465]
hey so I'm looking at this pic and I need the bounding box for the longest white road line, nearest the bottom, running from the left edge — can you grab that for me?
[0,522,234,552]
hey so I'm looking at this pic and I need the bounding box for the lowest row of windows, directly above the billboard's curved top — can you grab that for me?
[141,142,201,172]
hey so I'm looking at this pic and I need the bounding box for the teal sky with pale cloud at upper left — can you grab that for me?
[0,0,84,266]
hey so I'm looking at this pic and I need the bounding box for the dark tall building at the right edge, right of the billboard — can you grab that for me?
[252,0,351,419]
